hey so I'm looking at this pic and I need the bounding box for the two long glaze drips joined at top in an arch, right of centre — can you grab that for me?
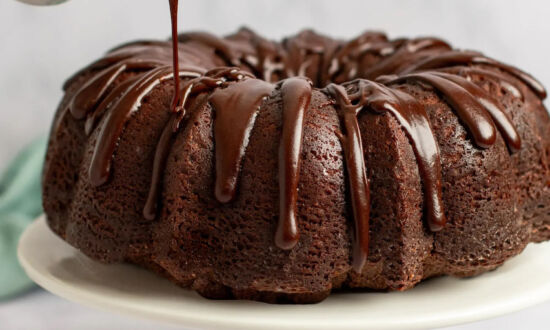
[324,80,447,272]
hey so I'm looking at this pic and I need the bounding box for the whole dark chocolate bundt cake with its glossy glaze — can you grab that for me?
[43,29,550,303]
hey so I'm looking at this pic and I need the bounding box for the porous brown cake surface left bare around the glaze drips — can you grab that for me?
[43,29,550,303]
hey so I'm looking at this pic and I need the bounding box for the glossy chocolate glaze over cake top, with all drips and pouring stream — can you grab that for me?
[58,0,546,272]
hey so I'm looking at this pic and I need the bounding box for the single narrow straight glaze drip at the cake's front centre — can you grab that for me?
[275,78,312,250]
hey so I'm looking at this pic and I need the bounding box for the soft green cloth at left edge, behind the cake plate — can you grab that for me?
[0,139,46,300]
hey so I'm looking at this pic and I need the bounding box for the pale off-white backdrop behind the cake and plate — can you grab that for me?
[0,0,550,329]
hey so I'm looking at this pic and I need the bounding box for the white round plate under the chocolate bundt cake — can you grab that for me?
[18,217,550,329]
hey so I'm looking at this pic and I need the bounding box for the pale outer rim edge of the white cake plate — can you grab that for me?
[17,215,550,329]
